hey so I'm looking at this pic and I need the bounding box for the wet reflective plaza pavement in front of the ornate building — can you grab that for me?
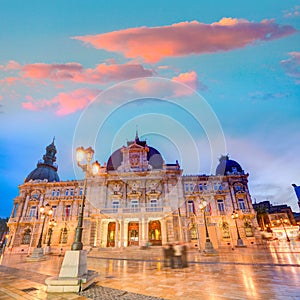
[0,241,300,300]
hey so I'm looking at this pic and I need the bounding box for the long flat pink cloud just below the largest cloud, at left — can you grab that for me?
[22,63,153,83]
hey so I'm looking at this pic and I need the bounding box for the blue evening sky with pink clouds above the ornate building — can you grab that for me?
[0,0,300,217]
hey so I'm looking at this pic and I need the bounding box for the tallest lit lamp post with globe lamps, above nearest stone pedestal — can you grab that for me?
[71,147,100,250]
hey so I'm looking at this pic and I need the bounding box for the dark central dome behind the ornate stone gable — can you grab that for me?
[106,135,164,171]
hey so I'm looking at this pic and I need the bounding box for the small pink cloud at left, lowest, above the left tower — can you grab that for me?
[22,89,100,116]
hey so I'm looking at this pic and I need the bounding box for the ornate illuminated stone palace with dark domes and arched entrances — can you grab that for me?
[7,135,260,253]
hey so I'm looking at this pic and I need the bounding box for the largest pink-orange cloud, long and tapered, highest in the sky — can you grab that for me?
[73,18,296,63]
